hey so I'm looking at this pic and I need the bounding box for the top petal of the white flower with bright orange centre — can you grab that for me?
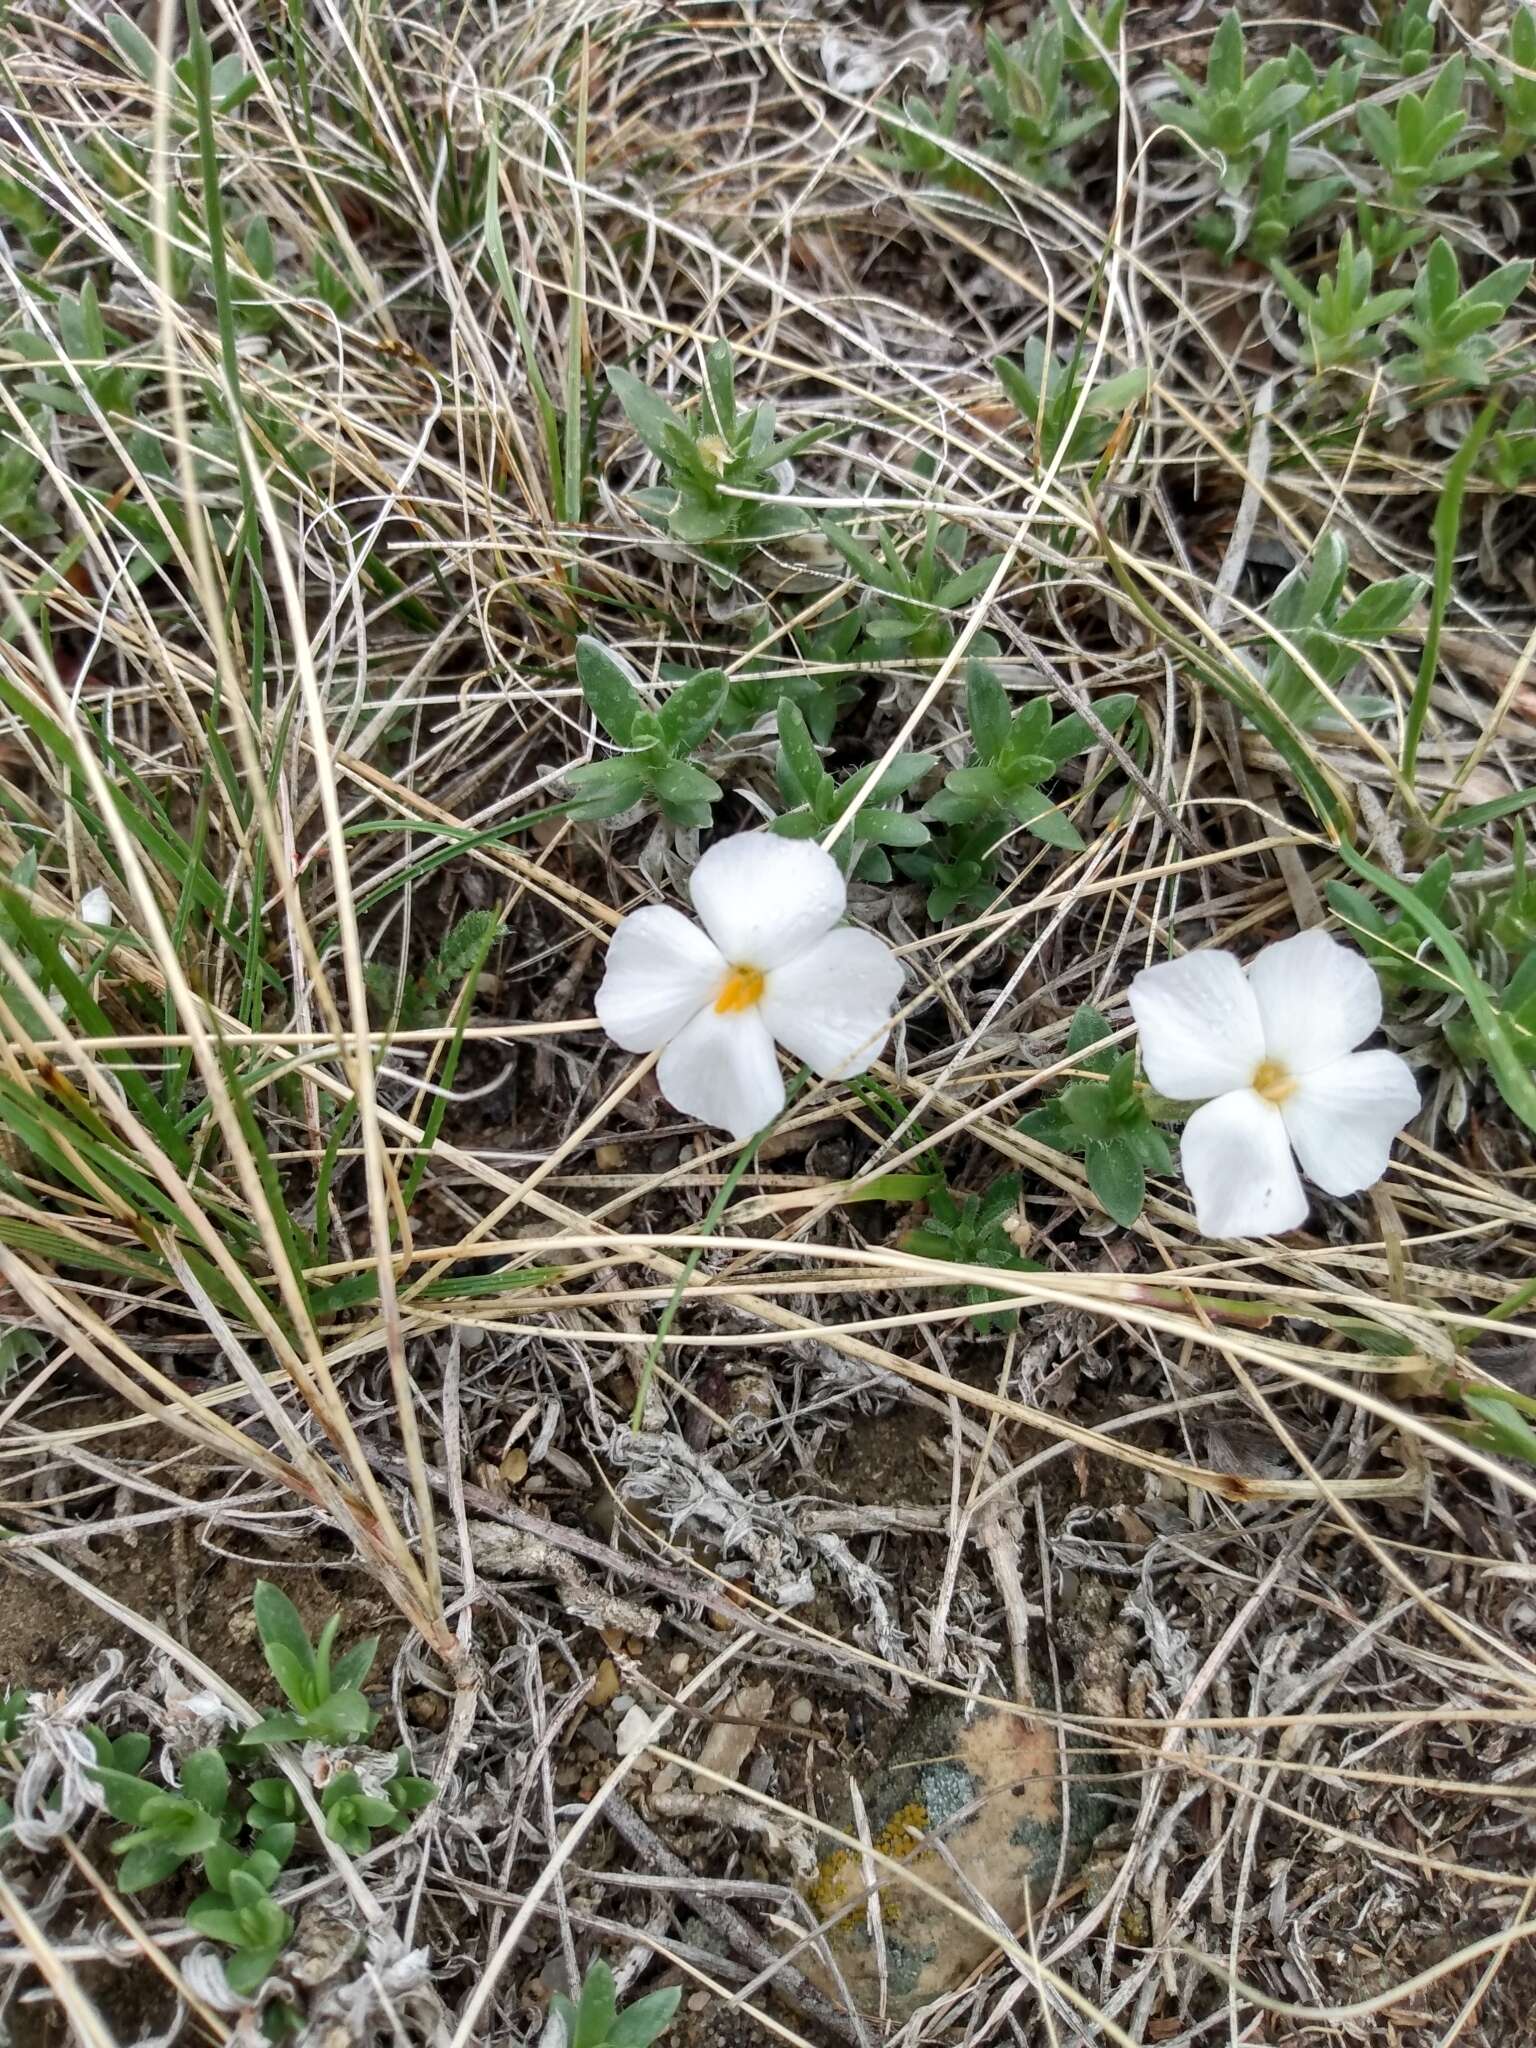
[688,831,848,973]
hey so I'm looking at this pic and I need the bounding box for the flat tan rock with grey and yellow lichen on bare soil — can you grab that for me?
[797,1700,1106,2019]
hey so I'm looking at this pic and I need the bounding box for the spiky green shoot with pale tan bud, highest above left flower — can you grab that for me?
[608,342,836,588]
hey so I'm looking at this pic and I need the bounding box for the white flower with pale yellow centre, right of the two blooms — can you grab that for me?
[1130,932,1419,1237]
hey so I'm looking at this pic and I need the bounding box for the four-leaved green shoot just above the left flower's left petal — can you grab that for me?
[565,635,729,829]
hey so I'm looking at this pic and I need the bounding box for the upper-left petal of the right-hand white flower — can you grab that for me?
[1130,952,1264,1102]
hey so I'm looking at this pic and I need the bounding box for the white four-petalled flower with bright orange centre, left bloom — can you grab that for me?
[598,831,901,1139]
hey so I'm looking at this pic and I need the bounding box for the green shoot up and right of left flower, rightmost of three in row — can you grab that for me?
[924,662,1137,852]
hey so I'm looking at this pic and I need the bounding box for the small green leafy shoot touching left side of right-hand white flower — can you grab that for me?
[1018,1004,1174,1227]
